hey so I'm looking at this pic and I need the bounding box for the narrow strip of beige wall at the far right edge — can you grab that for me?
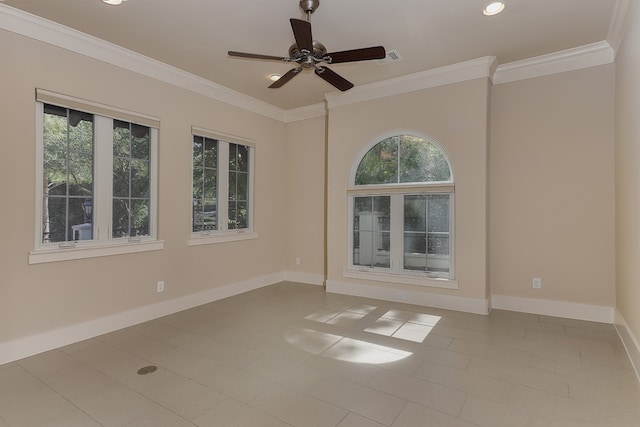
[616,2,640,352]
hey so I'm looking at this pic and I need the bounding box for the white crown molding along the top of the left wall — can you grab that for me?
[0,4,285,122]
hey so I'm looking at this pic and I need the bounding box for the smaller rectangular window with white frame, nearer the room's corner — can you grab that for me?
[189,127,257,245]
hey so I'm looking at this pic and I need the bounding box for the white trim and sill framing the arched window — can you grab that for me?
[342,130,458,289]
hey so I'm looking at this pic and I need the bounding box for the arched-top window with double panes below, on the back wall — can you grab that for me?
[349,134,454,284]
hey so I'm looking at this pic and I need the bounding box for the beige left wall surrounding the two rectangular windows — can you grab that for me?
[0,31,286,348]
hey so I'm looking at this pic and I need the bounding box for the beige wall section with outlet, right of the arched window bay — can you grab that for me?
[490,65,615,307]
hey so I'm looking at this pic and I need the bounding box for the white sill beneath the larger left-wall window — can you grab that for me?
[29,240,164,264]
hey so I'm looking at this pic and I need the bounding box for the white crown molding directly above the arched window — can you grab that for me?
[325,56,496,108]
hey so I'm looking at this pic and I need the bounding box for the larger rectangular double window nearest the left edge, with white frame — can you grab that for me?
[29,89,162,263]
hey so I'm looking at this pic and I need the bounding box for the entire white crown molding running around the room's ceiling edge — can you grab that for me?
[0,4,631,118]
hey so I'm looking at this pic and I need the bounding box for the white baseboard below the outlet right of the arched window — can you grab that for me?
[491,295,614,324]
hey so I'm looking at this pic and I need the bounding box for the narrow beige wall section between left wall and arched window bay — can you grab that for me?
[285,117,326,285]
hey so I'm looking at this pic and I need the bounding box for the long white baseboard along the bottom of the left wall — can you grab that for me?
[0,272,285,365]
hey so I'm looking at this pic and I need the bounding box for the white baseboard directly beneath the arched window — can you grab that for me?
[327,280,489,314]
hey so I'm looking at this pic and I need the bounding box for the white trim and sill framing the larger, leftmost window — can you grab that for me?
[28,89,164,264]
